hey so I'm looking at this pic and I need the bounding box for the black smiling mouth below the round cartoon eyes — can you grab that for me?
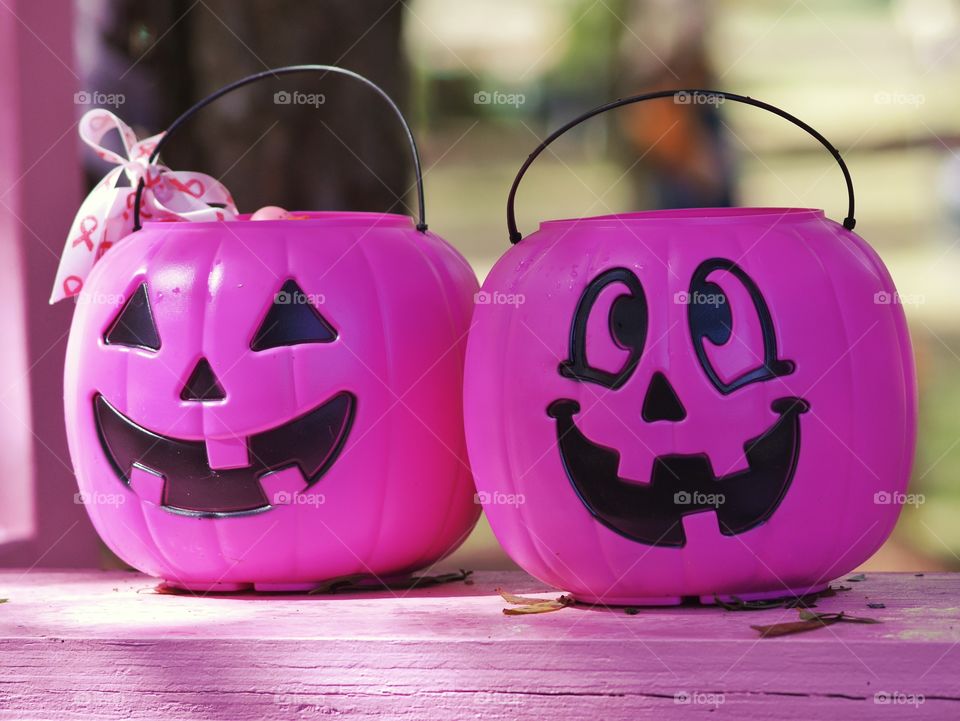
[547,398,809,547]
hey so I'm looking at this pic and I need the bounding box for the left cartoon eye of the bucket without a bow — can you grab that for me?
[560,268,648,389]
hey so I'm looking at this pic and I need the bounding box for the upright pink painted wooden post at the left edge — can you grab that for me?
[0,0,100,567]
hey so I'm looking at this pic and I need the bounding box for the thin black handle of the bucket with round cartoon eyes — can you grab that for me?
[507,89,857,243]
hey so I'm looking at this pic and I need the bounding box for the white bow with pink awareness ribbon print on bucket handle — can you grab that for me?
[50,108,237,303]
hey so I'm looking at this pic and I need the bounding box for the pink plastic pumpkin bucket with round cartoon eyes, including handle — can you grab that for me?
[465,91,917,604]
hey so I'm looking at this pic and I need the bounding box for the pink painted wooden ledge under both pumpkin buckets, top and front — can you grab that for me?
[0,571,960,721]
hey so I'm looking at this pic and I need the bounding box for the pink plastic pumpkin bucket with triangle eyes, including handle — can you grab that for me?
[65,66,479,591]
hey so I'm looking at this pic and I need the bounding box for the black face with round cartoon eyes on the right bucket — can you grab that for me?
[547,258,809,546]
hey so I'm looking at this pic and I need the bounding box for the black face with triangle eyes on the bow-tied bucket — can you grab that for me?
[93,279,356,515]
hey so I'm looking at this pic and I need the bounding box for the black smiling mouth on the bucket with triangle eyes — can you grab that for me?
[93,392,356,516]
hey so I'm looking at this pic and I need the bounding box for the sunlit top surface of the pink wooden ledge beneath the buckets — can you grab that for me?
[0,570,960,644]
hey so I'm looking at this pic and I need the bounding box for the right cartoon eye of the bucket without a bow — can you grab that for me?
[687,258,794,395]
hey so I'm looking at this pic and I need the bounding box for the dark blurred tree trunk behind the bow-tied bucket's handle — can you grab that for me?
[85,0,412,212]
